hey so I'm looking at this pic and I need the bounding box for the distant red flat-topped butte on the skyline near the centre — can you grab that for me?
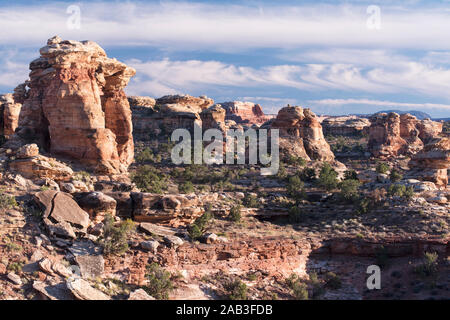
[221,101,275,125]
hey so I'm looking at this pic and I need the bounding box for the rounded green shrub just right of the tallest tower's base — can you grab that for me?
[131,166,167,194]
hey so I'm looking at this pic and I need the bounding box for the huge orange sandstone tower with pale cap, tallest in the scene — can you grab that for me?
[14,37,135,174]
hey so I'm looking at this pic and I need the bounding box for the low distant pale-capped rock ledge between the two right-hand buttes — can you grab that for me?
[322,116,370,136]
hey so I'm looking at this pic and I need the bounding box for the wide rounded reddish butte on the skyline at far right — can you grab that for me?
[368,112,442,157]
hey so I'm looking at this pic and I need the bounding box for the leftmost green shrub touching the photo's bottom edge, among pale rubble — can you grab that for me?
[144,262,174,300]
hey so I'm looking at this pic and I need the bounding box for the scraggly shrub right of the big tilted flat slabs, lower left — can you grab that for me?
[99,214,136,255]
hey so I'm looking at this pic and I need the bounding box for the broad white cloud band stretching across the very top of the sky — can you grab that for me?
[0,1,450,51]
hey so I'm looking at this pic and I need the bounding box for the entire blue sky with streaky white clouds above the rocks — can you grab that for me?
[0,0,450,118]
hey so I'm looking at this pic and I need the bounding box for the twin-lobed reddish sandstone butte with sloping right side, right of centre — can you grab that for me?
[271,106,334,161]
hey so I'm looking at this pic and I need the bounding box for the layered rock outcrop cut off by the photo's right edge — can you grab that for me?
[409,138,450,186]
